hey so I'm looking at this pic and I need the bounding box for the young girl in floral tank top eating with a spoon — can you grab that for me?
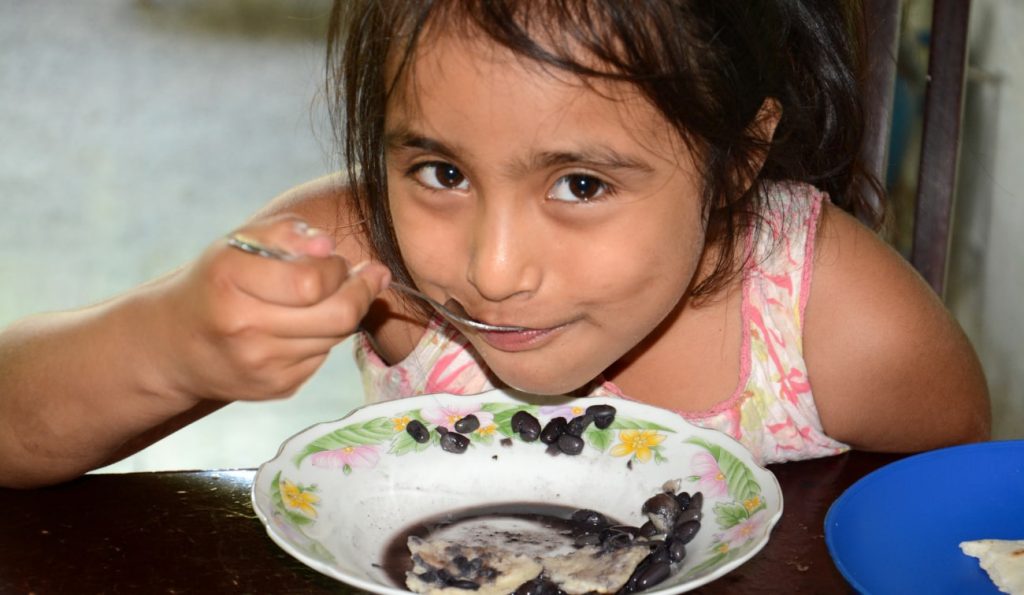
[0,0,989,485]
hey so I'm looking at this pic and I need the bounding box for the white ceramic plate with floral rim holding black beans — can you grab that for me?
[252,390,782,595]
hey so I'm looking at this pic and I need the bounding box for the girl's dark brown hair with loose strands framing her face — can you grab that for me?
[328,0,882,297]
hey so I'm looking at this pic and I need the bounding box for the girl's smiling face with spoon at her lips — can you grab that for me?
[386,35,705,394]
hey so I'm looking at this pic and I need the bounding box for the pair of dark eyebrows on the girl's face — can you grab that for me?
[384,128,654,174]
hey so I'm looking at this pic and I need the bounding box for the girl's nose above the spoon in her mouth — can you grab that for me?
[467,204,542,302]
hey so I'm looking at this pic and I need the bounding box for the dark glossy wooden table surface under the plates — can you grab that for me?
[0,453,898,595]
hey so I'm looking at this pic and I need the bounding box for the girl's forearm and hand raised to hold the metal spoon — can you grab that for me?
[0,181,389,486]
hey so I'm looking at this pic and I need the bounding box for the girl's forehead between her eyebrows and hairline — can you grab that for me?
[386,29,679,155]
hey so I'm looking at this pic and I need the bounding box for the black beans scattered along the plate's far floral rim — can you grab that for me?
[406,405,615,455]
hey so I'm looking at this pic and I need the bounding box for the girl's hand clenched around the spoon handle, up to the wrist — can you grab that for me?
[160,216,390,400]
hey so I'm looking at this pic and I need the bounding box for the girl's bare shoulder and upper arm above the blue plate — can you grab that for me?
[804,204,990,452]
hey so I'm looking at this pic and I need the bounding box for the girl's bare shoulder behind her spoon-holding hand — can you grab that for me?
[253,174,425,364]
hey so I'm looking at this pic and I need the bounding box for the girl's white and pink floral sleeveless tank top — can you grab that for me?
[354,183,849,465]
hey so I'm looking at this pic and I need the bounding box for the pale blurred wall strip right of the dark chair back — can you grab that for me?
[947,0,1024,437]
